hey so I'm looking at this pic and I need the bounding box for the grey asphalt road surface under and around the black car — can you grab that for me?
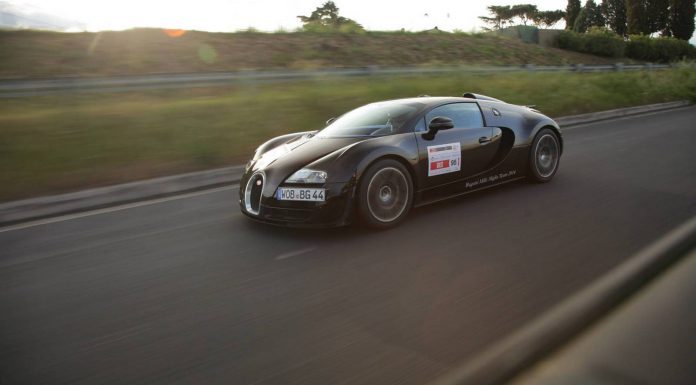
[0,107,696,385]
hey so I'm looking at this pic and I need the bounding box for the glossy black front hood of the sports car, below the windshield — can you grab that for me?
[249,136,370,189]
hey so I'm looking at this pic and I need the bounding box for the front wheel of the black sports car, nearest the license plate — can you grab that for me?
[358,159,413,229]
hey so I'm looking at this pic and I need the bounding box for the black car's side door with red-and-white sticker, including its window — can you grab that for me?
[416,102,497,188]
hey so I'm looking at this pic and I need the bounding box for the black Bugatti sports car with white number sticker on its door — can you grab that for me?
[239,93,563,228]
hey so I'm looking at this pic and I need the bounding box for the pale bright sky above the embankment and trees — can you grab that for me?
[0,0,696,43]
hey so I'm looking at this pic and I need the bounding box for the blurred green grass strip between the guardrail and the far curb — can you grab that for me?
[0,69,696,201]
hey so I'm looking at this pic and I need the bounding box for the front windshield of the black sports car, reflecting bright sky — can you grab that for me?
[317,102,420,138]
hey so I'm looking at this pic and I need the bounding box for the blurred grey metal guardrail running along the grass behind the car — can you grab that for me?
[0,63,672,98]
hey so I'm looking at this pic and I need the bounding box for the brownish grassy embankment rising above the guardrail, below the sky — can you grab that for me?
[0,29,625,79]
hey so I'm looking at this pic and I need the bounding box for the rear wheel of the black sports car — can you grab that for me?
[528,128,561,183]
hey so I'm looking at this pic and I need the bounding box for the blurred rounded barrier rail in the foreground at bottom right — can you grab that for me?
[429,217,696,385]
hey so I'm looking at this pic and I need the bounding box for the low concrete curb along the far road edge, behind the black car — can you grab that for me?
[0,101,689,226]
